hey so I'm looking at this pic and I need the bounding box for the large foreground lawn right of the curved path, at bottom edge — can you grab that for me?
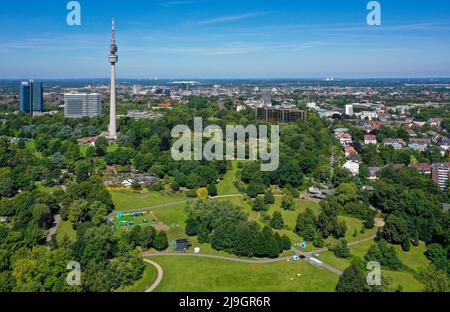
[151,256,338,292]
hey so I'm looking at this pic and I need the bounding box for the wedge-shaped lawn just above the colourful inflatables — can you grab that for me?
[110,189,187,211]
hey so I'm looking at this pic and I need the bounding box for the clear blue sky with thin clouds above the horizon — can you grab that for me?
[0,0,450,79]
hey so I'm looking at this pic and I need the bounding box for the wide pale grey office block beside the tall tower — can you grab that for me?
[64,93,102,118]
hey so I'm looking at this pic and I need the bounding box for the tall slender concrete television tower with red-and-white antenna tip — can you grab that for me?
[109,17,119,139]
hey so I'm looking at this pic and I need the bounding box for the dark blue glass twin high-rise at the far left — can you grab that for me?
[19,80,44,115]
